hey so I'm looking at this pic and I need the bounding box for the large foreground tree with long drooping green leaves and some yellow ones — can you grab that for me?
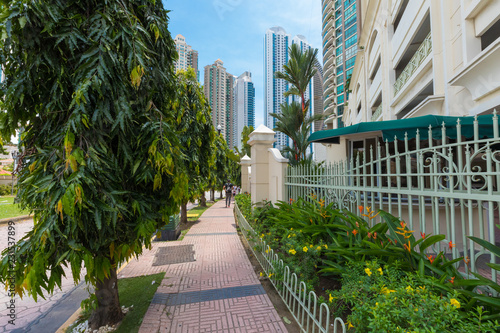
[0,0,185,327]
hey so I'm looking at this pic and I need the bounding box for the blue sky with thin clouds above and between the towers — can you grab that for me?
[163,0,322,126]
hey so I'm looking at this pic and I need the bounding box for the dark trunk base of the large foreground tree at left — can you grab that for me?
[89,262,124,330]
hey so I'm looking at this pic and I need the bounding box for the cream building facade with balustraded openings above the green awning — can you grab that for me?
[316,0,500,160]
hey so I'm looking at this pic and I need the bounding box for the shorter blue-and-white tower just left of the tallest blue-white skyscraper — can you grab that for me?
[233,72,255,149]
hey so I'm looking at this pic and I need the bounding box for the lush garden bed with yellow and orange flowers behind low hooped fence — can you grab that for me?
[236,195,500,332]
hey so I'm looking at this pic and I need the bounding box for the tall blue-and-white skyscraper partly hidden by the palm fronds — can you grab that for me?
[264,27,291,149]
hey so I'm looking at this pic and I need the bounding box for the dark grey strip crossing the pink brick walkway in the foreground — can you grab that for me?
[151,284,266,306]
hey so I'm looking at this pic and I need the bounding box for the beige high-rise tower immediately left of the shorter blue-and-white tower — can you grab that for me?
[203,59,235,148]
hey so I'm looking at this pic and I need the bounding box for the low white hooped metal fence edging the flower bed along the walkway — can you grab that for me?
[235,205,346,333]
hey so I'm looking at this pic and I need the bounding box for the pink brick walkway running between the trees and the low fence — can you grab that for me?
[119,201,287,333]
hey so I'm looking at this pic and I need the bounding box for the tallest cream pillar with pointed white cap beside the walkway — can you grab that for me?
[248,125,276,207]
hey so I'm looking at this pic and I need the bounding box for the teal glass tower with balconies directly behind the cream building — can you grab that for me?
[322,0,358,128]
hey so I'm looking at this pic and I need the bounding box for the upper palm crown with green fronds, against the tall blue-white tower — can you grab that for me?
[274,44,318,114]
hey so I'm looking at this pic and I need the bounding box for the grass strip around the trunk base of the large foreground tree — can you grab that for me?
[66,272,165,333]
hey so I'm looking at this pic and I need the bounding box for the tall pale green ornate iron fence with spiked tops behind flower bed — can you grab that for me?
[285,111,500,286]
